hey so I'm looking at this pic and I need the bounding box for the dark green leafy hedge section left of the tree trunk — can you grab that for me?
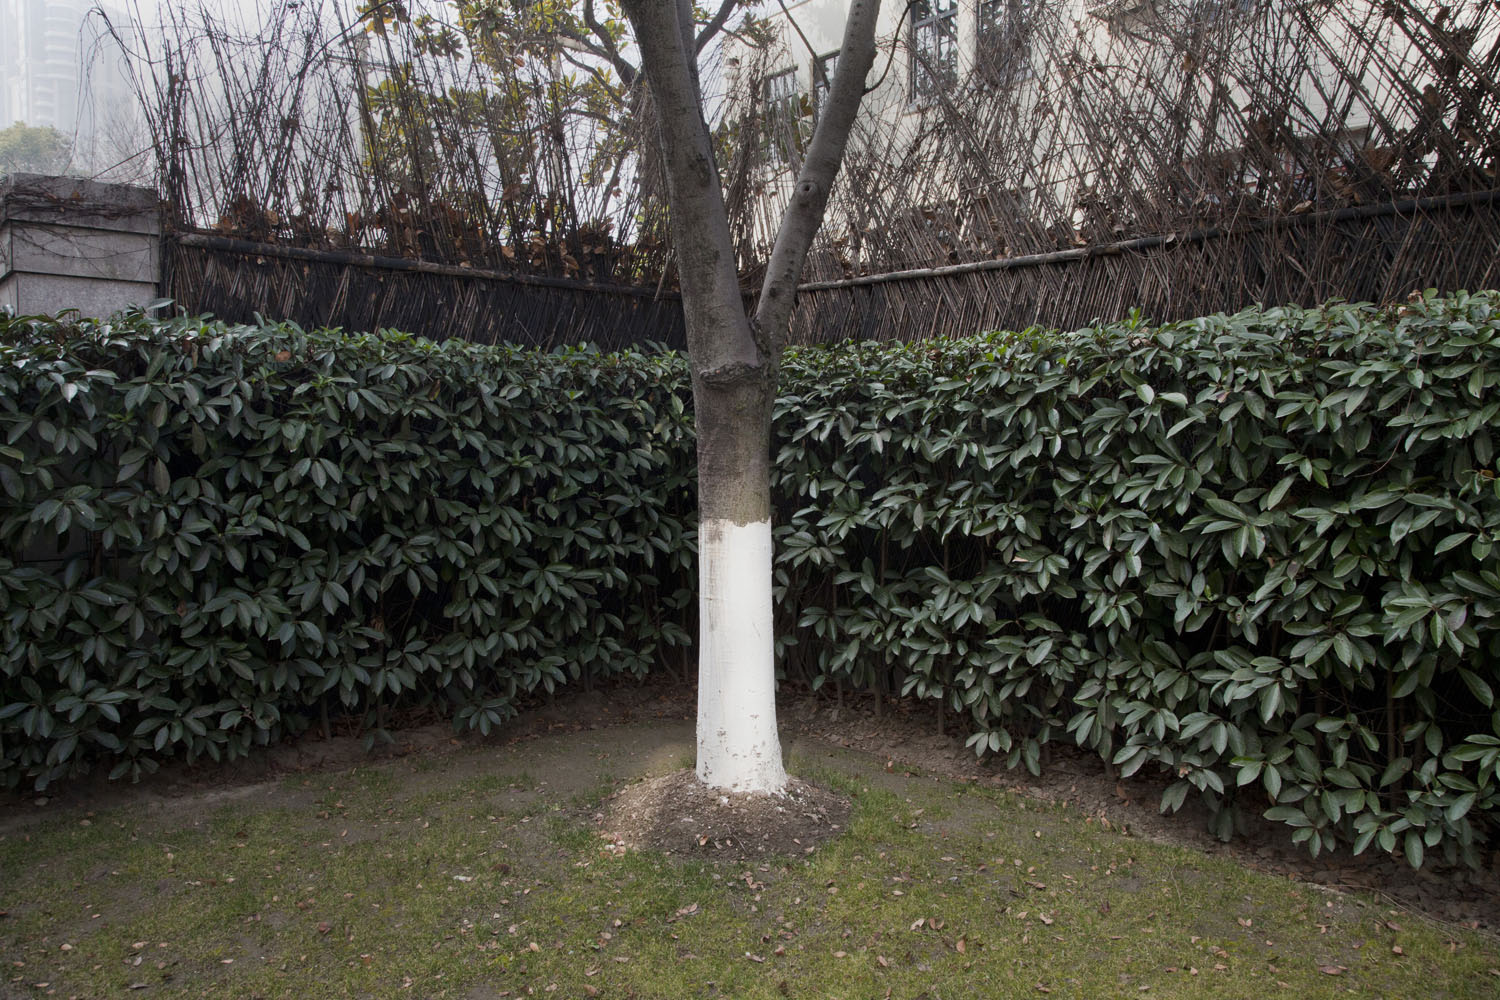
[0,316,695,787]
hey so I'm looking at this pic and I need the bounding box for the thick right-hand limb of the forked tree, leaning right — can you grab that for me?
[753,0,881,347]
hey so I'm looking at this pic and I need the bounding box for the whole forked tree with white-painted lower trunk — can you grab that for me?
[623,0,879,792]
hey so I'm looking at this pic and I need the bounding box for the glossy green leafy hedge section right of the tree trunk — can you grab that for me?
[776,294,1500,865]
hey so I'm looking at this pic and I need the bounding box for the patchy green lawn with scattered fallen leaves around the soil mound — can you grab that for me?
[0,727,1500,1000]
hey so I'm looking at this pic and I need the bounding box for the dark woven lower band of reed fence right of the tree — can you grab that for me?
[792,192,1500,343]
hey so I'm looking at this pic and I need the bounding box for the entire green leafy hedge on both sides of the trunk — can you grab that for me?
[0,292,1500,864]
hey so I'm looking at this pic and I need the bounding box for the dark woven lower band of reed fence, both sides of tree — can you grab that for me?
[164,192,1500,349]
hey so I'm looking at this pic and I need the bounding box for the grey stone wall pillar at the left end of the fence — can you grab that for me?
[0,174,162,316]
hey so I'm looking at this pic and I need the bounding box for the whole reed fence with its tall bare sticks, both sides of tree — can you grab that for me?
[137,0,1500,346]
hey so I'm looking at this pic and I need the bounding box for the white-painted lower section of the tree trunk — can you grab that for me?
[698,517,786,795]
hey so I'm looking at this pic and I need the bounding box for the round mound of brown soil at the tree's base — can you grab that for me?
[596,771,851,861]
